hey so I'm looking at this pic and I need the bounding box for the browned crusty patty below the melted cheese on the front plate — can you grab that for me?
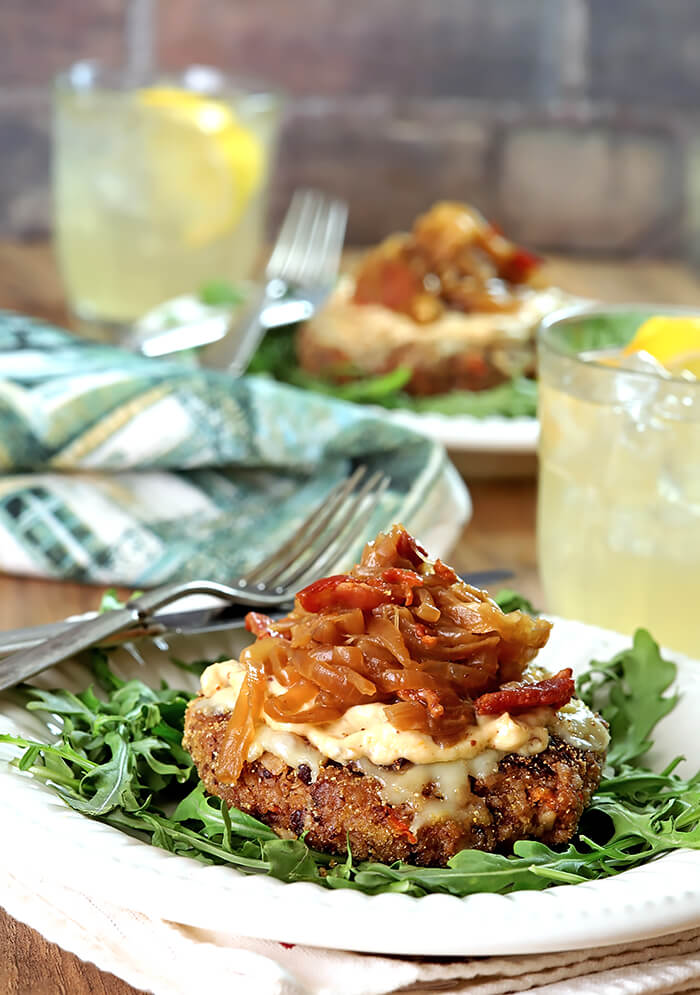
[183,706,603,865]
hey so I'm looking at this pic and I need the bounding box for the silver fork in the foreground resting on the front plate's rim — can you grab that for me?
[0,466,390,689]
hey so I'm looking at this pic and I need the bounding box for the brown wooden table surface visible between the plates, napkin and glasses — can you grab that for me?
[0,243,700,995]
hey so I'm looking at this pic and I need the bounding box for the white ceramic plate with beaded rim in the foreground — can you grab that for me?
[0,621,700,956]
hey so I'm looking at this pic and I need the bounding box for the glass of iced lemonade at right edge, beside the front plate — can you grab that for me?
[537,306,700,658]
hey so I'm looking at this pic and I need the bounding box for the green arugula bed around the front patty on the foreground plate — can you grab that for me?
[0,592,700,897]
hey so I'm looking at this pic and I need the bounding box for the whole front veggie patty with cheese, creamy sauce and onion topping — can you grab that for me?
[183,526,608,865]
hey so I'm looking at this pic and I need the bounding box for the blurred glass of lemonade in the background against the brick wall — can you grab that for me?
[53,62,280,341]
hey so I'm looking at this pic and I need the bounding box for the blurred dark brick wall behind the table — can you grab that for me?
[0,0,700,256]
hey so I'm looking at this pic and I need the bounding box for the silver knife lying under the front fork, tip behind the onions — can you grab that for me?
[0,570,513,691]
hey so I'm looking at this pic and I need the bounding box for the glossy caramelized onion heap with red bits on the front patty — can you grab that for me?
[216,525,556,782]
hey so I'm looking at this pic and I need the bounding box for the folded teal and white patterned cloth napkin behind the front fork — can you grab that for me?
[0,312,465,587]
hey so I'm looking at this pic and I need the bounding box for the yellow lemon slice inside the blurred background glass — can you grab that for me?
[136,86,266,248]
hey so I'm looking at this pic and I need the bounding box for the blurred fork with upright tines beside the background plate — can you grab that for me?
[202,190,348,376]
